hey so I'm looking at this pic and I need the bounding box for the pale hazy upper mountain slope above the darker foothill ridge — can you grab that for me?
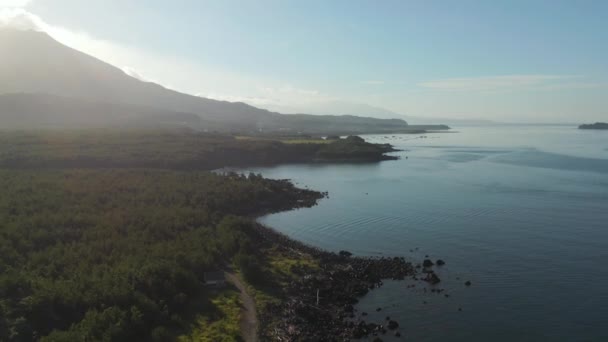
[0,29,269,128]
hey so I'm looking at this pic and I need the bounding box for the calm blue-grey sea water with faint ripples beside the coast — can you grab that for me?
[253,126,608,341]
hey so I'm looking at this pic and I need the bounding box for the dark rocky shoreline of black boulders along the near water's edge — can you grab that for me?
[248,224,443,341]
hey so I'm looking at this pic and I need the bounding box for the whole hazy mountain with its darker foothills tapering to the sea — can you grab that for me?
[0,28,448,134]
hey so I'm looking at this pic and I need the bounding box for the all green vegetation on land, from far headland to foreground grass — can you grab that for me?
[0,130,400,341]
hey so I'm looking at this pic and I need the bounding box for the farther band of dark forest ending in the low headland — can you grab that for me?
[0,130,394,170]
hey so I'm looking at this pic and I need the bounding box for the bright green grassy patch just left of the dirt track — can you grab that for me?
[178,290,243,342]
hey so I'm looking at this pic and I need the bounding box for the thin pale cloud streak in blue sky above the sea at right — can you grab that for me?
[419,75,580,91]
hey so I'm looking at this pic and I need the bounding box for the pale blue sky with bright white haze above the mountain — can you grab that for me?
[0,0,608,123]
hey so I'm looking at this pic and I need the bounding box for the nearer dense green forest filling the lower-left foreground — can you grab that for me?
[0,169,321,341]
